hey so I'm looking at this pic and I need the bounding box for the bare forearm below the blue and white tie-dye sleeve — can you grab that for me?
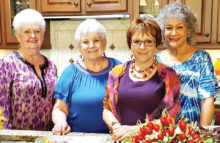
[200,96,215,126]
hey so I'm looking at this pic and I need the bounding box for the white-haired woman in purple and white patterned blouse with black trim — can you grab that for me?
[0,9,57,130]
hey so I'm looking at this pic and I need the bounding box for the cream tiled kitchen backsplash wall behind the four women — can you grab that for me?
[0,19,220,76]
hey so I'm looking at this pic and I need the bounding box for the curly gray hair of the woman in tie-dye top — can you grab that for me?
[156,1,197,46]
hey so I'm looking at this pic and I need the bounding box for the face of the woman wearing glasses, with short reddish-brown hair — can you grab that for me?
[131,33,157,63]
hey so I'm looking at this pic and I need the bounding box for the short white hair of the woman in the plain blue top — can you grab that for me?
[75,19,106,43]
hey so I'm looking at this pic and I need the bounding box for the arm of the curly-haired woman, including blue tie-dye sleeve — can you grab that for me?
[198,50,219,126]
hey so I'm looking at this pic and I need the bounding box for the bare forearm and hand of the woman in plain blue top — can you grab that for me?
[52,98,71,135]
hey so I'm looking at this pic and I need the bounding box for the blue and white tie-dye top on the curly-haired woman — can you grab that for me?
[157,50,219,123]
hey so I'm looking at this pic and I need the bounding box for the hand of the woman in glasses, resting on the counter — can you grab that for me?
[112,124,139,141]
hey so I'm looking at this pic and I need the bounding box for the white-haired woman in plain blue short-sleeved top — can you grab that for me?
[52,19,121,135]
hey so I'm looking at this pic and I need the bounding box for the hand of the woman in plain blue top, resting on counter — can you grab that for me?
[52,122,71,135]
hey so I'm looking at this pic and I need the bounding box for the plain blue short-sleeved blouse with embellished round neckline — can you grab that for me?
[54,58,121,133]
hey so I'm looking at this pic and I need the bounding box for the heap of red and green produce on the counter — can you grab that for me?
[124,110,214,143]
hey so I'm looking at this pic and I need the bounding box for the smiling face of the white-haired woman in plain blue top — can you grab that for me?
[78,32,107,60]
